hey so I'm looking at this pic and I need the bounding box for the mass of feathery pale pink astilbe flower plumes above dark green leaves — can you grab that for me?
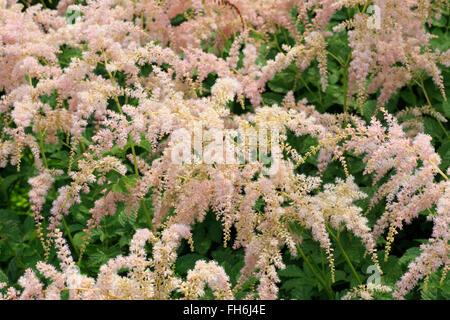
[0,0,450,299]
